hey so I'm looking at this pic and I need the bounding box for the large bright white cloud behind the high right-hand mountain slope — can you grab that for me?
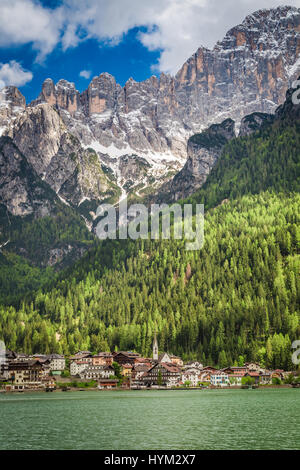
[140,0,300,74]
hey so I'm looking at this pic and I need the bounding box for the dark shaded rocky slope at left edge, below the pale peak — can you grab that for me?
[0,136,90,272]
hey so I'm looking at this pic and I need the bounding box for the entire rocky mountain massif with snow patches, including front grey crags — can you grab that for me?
[0,7,300,272]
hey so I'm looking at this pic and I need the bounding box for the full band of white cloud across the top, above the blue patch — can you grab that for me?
[0,0,300,73]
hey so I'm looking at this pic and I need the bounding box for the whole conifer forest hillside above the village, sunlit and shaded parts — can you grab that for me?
[0,87,300,369]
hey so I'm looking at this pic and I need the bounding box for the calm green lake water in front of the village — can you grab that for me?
[0,389,300,450]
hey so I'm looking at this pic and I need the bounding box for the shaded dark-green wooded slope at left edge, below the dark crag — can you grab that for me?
[0,202,94,305]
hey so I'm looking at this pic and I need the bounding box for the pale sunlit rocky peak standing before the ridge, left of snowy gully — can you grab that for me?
[6,103,118,211]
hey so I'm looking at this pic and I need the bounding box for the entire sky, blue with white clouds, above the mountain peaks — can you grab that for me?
[0,0,300,102]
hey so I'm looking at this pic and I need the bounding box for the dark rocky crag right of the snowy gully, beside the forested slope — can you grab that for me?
[170,119,235,200]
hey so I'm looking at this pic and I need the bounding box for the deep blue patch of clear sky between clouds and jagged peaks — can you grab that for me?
[0,28,159,102]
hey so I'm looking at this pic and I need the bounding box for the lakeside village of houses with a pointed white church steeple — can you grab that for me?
[0,336,300,392]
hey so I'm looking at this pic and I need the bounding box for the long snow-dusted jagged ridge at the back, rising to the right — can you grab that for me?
[0,7,300,204]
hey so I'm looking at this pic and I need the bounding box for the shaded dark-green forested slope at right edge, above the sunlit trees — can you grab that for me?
[185,86,300,209]
